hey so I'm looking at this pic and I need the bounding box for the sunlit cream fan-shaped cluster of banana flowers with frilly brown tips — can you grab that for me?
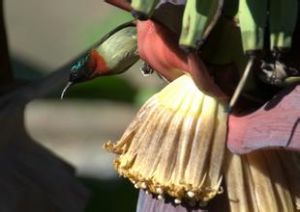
[106,75,228,203]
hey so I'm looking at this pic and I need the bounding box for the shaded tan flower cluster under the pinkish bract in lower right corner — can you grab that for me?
[224,149,300,212]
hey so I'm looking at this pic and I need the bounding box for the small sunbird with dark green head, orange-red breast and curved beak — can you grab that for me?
[62,21,139,96]
